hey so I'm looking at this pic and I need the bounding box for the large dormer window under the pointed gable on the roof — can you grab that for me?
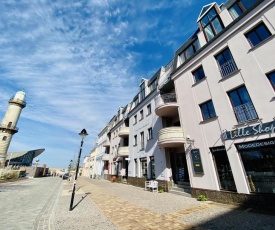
[200,7,224,41]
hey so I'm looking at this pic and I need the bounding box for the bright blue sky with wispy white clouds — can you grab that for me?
[0,0,223,168]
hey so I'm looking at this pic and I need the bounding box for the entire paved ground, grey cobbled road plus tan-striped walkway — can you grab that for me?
[0,177,275,230]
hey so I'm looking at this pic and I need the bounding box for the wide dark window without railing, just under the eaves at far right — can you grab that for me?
[245,23,271,46]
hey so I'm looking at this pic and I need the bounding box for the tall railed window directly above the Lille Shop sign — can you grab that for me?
[228,86,258,123]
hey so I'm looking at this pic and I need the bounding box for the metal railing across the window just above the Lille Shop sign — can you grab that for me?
[234,102,258,123]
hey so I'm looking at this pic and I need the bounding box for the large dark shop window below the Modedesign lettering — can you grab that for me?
[240,147,275,193]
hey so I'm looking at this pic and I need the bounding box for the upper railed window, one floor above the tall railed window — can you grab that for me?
[215,48,238,77]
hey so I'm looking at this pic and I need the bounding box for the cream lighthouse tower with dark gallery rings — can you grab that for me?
[0,91,26,168]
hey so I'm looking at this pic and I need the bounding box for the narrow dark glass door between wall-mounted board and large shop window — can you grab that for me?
[212,151,237,191]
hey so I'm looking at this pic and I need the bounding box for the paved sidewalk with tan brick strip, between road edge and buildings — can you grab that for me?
[54,177,275,230]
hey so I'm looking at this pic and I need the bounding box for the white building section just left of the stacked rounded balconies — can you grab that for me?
[127,74,168,186]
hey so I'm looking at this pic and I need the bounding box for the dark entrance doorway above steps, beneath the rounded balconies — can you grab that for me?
[170,153,189,184]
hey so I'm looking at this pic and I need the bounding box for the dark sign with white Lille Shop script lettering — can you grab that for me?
[222,121,275,140]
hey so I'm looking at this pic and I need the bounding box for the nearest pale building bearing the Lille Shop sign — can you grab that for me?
[168,0,275,205]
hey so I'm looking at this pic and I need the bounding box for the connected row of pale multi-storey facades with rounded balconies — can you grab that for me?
[88,0,275,207]
